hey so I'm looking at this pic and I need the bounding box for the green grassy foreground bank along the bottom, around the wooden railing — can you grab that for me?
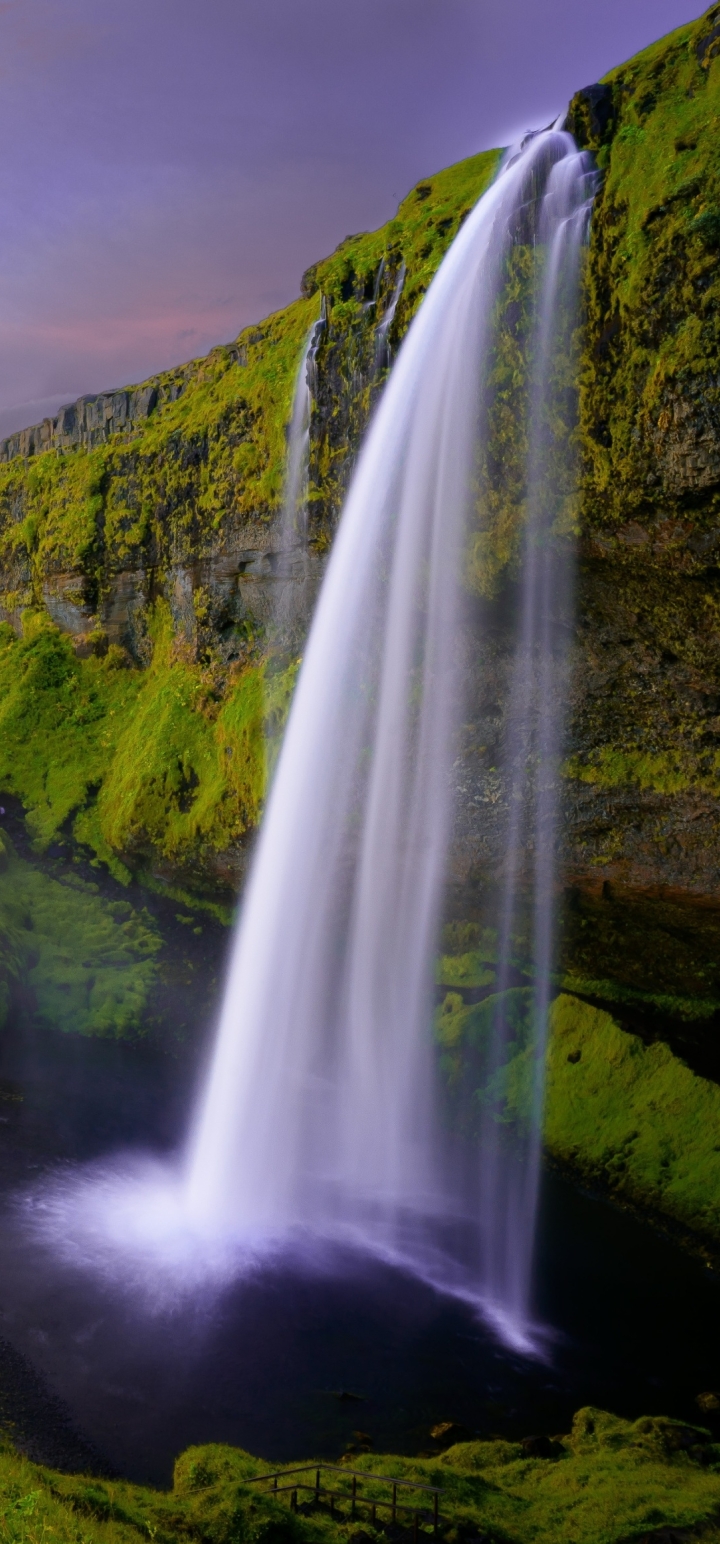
[0,1408,720,1544]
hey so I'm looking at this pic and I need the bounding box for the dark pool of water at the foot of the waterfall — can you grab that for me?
[0,1012,720,1484]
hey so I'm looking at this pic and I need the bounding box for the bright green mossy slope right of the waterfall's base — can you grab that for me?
[436,956,720,1248]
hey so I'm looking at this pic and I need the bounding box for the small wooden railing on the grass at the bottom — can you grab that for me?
[247,1464,440,1541]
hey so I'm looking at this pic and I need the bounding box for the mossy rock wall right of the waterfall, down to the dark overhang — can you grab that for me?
[565,6,720,897]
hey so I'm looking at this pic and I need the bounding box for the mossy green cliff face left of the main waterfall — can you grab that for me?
[0,151,498,902]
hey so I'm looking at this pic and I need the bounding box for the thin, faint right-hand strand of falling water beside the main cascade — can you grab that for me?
[479,136,596,1323]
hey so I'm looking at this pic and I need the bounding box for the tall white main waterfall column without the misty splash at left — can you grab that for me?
[185,130,592,1325]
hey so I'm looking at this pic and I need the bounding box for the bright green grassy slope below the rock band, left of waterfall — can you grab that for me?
[0,601,297,880]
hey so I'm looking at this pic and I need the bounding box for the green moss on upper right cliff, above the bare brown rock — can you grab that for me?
[582,8,720,528]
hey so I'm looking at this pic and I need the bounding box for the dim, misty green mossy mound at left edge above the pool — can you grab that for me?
[0,837,161,1036]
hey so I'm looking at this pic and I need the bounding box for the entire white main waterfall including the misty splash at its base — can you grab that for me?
[20,130,595,1353]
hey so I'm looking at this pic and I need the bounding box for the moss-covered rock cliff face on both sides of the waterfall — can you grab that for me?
[0,6,720,1044]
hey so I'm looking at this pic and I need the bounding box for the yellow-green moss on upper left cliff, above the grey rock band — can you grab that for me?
[0,151,499,611]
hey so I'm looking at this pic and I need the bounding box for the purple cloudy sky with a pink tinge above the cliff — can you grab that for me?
[0,0,701,434]
